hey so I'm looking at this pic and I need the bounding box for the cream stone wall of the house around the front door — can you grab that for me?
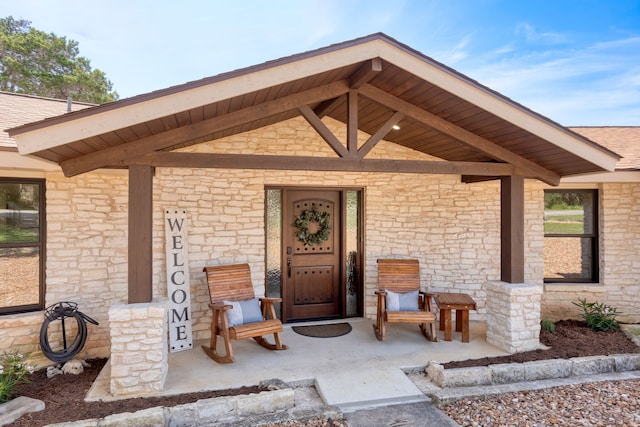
[0,119,640,372]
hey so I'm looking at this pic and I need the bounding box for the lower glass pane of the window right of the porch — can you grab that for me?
[544,237,594,280]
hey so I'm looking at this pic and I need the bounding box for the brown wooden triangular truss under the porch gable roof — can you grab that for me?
[61,59,560,185]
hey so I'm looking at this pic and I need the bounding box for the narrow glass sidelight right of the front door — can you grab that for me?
[345,191,360,317]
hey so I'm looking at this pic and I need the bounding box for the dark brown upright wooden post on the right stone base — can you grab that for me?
[500,176,524,283]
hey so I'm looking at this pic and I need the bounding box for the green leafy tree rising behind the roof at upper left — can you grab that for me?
[0,16,118,104]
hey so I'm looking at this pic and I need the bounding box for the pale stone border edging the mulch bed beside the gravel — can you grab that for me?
[425,353,640,388]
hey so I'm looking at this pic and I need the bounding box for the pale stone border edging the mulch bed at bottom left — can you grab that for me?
[46,388,294,427]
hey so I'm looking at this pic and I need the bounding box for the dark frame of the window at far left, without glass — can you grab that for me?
[0,177,47,316]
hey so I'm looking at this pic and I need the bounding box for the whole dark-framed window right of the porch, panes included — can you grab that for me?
[544,190,598,283]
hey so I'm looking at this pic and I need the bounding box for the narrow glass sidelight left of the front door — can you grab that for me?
[266,190,282,318]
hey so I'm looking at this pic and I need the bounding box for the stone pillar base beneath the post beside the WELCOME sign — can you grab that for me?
[109,301,168,396]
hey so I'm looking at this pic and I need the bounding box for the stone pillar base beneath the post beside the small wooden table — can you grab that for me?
[486,281,544,353]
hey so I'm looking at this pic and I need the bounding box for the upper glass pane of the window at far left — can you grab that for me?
[0,183,40,243]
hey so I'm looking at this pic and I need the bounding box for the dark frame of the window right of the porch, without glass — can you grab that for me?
[543,188,600,285]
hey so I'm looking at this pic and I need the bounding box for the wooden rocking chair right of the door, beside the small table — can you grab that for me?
[373,259,438,342]
